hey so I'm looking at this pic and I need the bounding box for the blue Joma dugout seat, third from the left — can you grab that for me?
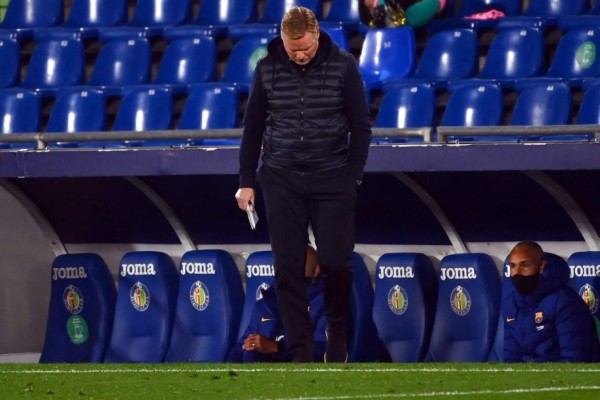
[165,250,244,362]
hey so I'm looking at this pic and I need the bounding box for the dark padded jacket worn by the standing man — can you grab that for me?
[240,32,371,187]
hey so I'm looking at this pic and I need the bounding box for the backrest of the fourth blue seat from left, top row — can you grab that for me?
[194,0,258,26]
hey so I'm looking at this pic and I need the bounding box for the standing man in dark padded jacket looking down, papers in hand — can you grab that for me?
[235,7,371,362]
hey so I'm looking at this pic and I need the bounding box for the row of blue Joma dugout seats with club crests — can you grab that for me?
[40,250,600,363]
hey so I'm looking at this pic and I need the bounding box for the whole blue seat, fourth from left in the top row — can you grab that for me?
[164,0,258,38]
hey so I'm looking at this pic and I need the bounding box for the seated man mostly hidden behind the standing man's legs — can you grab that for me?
[228,246,327,362]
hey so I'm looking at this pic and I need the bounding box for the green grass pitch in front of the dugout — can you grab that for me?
[0,363,600,400]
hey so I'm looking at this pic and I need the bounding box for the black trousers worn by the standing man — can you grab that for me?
[258,165,357,361]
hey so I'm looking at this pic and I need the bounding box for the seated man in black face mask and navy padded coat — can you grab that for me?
[502,242,598,362]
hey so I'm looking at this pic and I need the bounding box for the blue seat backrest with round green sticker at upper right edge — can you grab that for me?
[546,28,600,79]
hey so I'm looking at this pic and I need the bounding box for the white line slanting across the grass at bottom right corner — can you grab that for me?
[255,386,600,400]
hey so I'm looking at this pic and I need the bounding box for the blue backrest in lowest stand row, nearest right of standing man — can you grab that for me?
[375,83,435,128]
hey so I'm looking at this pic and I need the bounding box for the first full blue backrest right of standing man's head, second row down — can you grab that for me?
[359,28,418,84]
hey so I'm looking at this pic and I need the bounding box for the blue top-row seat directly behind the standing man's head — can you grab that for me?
[227,0,323,41]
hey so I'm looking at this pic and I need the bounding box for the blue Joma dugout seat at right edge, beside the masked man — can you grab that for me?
[567,251,600,339]
